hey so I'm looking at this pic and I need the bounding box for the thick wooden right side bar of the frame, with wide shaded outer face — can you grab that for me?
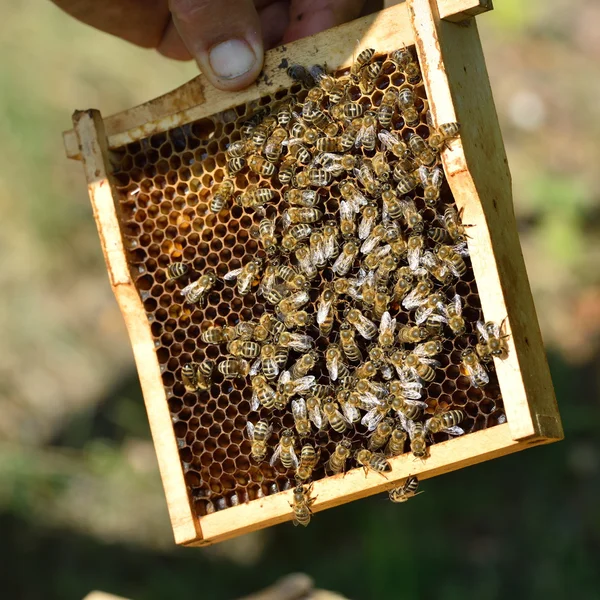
[409,0,563,440]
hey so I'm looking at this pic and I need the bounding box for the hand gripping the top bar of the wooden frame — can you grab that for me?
[53,0,365,90]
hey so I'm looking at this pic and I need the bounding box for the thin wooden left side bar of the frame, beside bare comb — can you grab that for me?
[73,110,201,544]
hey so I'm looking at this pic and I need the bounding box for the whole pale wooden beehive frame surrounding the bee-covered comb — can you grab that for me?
[65,0,563,546]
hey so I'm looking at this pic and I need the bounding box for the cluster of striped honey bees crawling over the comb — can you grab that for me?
[168,48,507,526]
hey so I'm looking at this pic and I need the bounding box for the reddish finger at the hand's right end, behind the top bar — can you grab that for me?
[283,0,365,43]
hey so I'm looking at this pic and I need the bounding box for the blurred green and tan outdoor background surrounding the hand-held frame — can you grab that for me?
[0,0,600,600]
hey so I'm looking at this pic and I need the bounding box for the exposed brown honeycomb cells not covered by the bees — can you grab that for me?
[111,50,504,516]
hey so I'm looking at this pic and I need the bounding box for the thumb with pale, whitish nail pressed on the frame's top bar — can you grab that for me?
[169,0,264,90]
